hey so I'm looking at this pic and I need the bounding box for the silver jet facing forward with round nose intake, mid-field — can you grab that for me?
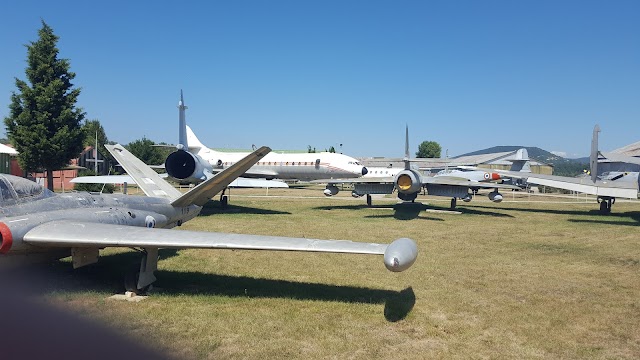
[317,127,520,209]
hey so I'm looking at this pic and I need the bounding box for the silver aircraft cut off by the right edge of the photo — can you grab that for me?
[488,125,640,214]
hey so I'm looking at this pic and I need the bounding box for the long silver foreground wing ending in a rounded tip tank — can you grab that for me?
[23,220,418,271]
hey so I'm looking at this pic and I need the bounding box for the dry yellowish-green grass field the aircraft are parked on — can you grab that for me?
[46,187,640,359]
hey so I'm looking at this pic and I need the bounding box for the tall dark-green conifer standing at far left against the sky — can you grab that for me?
[4,21,85,190]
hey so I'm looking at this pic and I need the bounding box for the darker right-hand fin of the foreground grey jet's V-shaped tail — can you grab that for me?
[171,146,271,207]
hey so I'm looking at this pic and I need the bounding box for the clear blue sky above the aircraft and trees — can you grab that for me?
[0,0,640,157]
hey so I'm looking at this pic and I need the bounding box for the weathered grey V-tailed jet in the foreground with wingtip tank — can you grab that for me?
[0,145,418,292]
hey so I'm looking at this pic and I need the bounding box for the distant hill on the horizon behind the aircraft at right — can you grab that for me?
[456,146,589,176]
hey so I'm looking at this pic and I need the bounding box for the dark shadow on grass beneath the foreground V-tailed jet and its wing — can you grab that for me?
[23,249,416,322]
